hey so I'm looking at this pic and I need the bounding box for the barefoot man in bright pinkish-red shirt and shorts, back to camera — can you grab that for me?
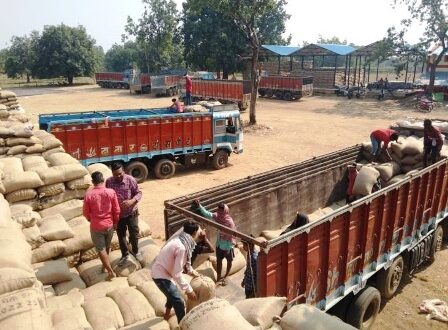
[83,172,120,280]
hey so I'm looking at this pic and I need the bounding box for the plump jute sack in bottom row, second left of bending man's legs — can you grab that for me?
[106,288,156,325]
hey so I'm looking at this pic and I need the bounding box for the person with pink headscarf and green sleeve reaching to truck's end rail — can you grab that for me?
[196,201,236,286]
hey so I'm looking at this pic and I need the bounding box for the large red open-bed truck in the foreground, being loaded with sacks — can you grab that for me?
[164,145,448,329]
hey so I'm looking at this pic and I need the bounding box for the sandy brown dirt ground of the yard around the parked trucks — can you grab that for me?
[20,86,448,329]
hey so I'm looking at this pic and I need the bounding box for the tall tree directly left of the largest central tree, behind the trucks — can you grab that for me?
[125,0,182,72]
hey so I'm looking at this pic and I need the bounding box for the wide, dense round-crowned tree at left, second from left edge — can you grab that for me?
[35,24,96,85]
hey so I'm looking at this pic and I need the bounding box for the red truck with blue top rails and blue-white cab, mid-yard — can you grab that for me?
[39,105,243,182]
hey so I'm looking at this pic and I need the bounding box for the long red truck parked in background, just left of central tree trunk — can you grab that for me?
[179,78,250,111]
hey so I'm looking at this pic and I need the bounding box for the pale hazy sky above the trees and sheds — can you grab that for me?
[0,0,422,51]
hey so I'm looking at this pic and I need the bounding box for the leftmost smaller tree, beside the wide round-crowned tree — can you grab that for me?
[5,31,39,83]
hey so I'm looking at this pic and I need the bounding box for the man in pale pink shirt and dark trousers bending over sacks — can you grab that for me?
[151,221,201,322]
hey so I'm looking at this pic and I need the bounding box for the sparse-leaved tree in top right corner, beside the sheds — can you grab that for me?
[385,0,448,93]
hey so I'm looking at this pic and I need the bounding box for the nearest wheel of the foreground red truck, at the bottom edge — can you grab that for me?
[346,286,381,330]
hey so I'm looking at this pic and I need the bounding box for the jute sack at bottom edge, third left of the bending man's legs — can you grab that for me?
[82,297,124,330]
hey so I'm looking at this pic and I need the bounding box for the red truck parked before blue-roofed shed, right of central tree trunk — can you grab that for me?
[258,76,313,101]
